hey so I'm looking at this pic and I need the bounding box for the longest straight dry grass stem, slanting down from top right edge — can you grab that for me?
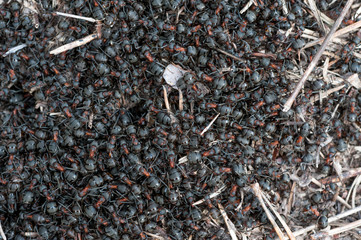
[283,0,354,112]
